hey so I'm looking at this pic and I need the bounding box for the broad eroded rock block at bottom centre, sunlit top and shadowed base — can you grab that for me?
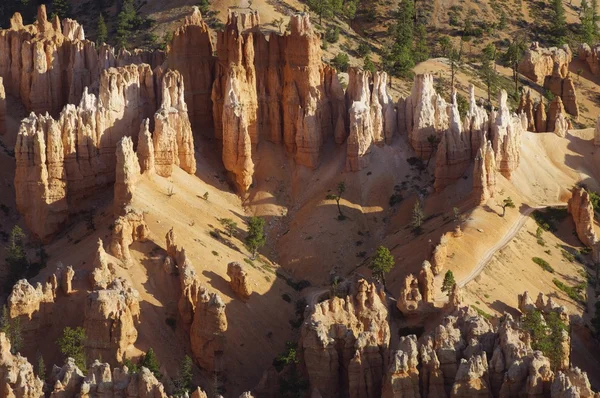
[300,280,390,397]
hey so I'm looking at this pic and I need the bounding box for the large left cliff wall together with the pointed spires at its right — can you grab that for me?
[15,64,196,241]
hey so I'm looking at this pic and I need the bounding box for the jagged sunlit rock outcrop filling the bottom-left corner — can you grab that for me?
[0,333,44,398]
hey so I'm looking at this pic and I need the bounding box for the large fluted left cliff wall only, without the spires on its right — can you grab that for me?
[15,65,154,240]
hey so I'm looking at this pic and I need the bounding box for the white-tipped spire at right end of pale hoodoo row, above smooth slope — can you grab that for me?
[491,90,523,179]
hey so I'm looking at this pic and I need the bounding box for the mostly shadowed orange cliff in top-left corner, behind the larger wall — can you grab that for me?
[0,5,164,116]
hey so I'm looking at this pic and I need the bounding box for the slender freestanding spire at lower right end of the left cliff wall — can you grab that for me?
[113,137,140,218]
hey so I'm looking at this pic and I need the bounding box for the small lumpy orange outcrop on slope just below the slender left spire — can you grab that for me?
[110,207,150,267]
